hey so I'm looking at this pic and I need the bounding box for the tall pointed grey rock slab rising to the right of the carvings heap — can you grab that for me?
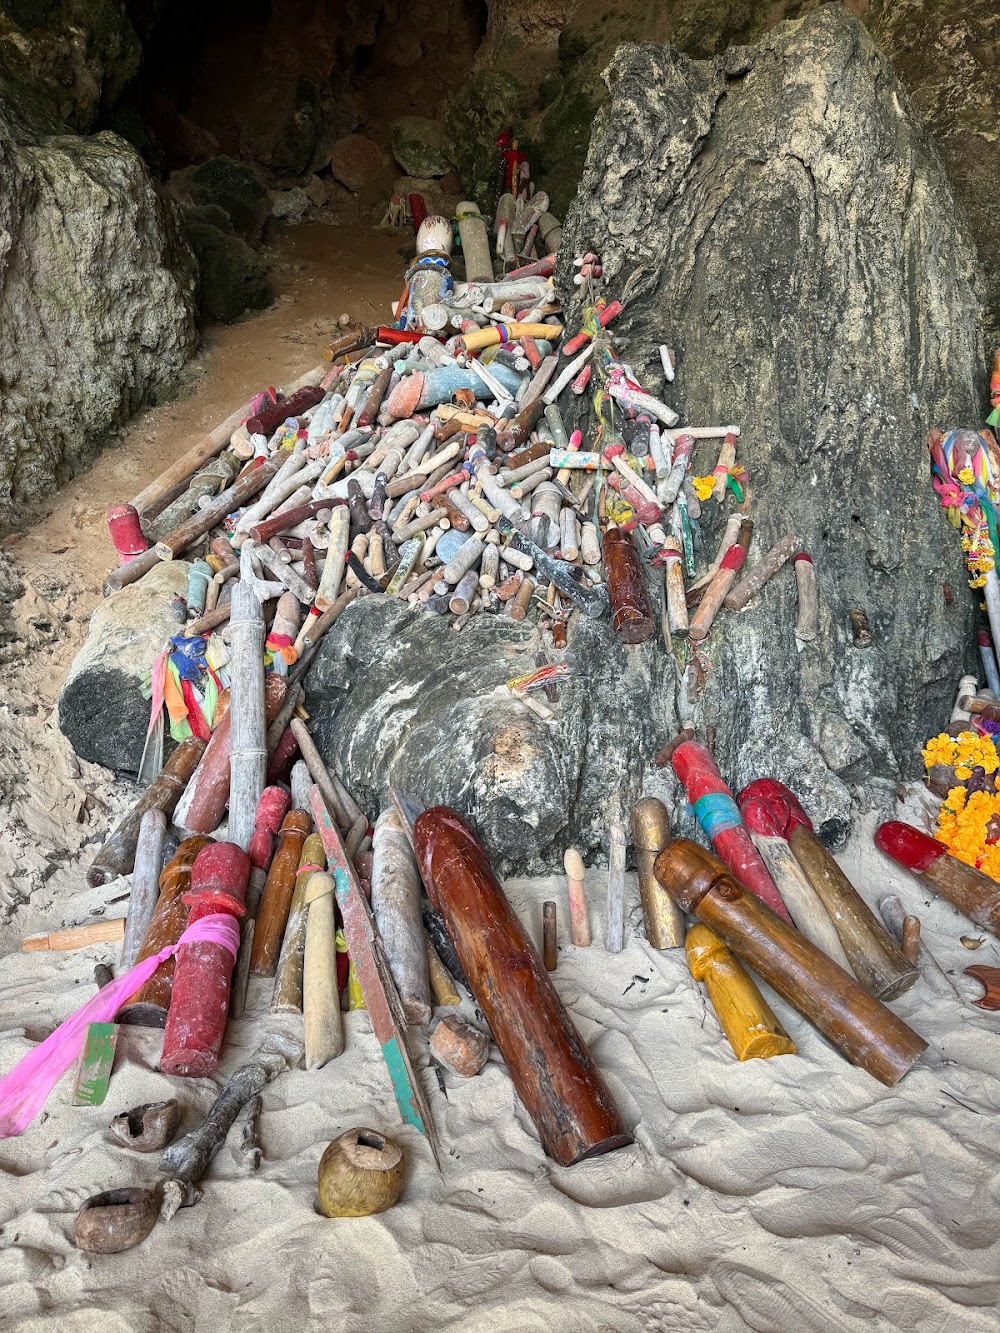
[557,5,987,837]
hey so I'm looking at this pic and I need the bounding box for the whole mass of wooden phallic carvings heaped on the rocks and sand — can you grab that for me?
[0,220,1000,1250]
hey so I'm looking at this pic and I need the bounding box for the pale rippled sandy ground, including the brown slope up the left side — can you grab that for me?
[0,225,1000,1333]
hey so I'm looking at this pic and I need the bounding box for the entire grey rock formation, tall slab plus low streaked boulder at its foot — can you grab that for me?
[308,5,984,870]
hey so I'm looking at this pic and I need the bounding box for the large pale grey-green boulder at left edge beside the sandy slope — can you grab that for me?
[0,113,196,528]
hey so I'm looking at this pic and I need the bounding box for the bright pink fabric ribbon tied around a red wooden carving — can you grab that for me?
[0,912,240,1138]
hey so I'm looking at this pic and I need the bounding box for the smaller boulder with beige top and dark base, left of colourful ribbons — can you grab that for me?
[59,560,191,773]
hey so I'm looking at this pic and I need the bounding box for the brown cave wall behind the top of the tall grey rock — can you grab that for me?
[448,0,1000,347]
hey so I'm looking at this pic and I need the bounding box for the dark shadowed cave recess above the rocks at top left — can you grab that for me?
[121,0,487,188]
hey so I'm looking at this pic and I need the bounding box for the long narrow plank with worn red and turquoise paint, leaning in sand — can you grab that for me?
[309,786,440,1162]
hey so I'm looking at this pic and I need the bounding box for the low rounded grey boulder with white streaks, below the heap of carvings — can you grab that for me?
[308,596,673,869]
